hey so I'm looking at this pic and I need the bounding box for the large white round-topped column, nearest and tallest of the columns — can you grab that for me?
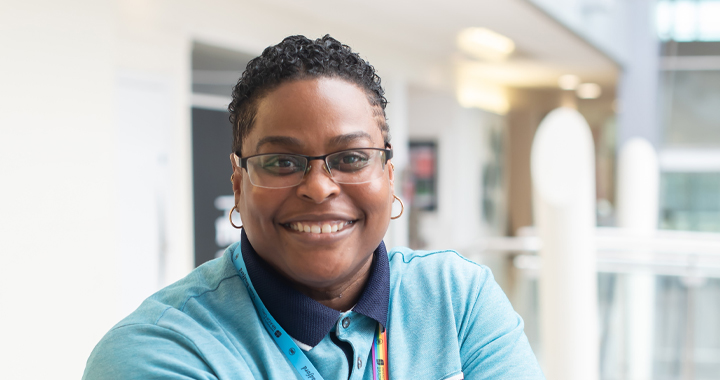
[531,108,599,380]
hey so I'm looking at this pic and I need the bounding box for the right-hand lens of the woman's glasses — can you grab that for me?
[327,149,386,183]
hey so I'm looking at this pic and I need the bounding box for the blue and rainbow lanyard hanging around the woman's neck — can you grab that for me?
[232,244,388,380]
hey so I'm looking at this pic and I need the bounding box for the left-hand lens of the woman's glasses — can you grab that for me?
[247,154,307,189]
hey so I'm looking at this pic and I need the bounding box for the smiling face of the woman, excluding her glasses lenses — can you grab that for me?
[233,78,393,289]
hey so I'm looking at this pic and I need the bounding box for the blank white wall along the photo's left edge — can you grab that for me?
[0,0,119,379]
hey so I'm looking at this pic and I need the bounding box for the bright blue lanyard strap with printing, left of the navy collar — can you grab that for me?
[232,244,323,380]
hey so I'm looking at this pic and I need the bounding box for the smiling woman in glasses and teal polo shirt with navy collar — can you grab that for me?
[84,36,543,380]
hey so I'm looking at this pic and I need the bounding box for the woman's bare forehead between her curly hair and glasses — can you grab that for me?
[243,78,384,155]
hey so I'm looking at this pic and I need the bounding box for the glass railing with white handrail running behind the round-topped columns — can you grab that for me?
[467,228,720,380]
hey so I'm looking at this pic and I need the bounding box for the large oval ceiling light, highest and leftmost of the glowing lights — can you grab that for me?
[457,28,515,60]
